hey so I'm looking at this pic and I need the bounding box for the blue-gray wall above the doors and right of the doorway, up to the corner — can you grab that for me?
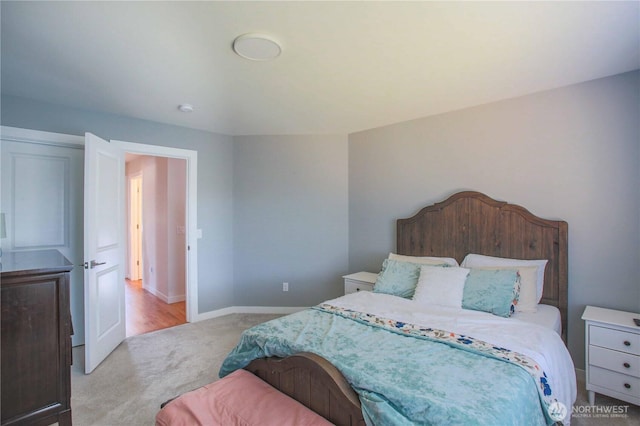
[1,96,234,313]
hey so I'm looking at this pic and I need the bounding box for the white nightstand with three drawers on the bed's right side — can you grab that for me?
[582,306,640,405]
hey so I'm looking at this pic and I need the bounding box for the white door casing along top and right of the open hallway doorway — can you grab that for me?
[111,140,199,322]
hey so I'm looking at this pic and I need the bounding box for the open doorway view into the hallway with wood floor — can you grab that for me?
[125,153,187,337]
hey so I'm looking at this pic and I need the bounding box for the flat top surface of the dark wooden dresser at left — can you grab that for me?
[0,250,73,277]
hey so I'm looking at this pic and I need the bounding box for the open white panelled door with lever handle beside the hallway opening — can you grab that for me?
[84,133,126,374]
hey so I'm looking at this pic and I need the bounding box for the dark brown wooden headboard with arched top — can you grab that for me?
[397,191,568,342]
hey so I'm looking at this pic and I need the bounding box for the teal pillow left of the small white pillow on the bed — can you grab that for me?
[373,259,447,299]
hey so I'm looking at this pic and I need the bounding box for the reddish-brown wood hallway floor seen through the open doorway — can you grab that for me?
[124,280,187,337]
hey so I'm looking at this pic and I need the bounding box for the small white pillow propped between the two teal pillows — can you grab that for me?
[413,265,470,308]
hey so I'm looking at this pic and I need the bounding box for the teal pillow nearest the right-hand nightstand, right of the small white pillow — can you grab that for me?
[462,268,520,318]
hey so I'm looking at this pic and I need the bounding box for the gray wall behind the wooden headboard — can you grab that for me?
[349,72,640,368]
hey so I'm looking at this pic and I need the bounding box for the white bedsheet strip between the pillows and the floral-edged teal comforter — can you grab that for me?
[325,291,577,424]
